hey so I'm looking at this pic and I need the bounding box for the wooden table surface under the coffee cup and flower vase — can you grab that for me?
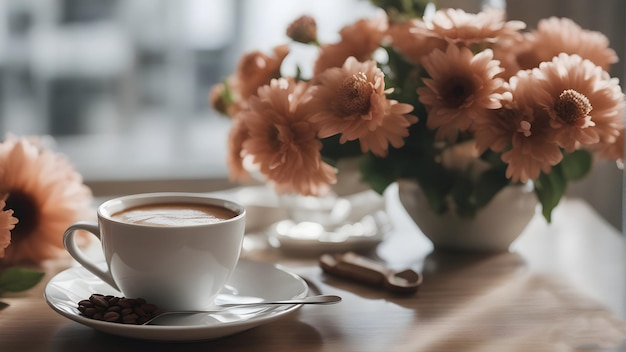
[0,186,626,352]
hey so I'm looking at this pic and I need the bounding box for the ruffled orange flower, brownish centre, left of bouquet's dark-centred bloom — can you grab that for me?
[311,57,417,156]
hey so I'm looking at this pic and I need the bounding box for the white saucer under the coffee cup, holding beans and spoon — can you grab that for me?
[44,259,309,341]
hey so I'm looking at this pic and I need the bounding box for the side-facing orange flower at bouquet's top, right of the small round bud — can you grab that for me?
[313,11,388,76]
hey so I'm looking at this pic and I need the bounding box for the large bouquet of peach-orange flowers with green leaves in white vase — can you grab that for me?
[210,0,624,221]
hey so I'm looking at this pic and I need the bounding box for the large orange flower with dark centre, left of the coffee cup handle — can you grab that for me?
[0,138,92,263]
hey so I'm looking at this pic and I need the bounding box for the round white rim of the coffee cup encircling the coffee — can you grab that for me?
[97,192,246,228]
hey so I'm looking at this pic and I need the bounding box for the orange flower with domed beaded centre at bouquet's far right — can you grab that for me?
[528,54,624,152]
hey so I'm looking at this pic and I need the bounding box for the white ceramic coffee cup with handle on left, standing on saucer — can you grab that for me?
[63,192,246,310]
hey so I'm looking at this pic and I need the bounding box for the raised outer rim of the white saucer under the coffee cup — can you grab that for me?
[43,258,310,341]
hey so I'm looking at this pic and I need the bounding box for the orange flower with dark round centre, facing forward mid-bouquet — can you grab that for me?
[417,44,504,142]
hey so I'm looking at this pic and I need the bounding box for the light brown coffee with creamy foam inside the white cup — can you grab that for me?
[111,203,237,227]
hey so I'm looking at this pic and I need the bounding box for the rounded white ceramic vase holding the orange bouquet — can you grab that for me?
[398,181,537,252]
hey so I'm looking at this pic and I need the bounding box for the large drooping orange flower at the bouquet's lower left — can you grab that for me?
[239,78,337,195]
